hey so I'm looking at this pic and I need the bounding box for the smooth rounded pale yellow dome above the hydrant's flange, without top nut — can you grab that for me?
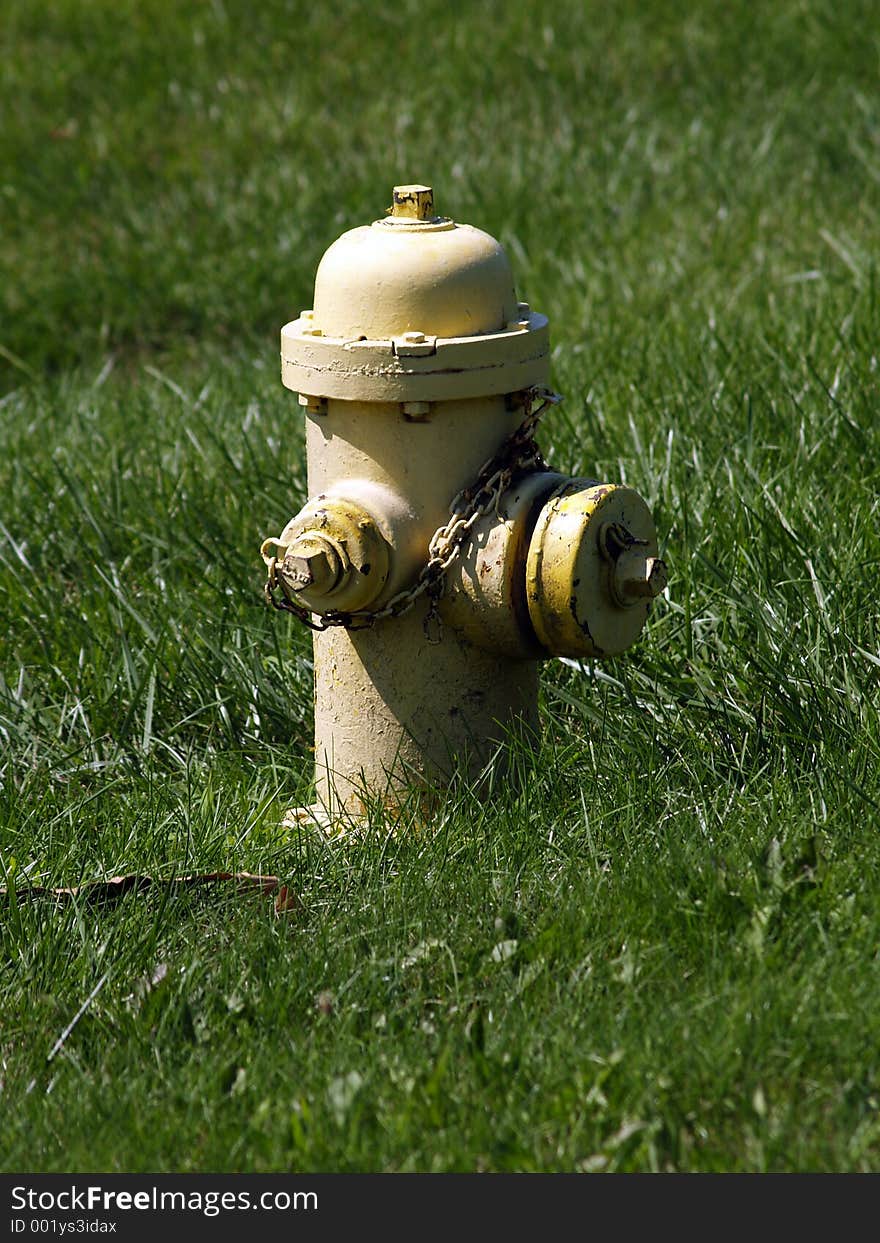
[314,220,518,339]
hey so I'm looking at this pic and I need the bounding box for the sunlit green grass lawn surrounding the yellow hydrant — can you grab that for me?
[0,0,880,1171]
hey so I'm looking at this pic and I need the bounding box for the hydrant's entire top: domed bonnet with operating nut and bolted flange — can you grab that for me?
[281,186,549,401]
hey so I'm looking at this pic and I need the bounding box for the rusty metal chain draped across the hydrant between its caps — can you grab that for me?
[262,388,562,643]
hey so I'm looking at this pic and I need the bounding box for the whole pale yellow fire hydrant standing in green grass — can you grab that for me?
[262,185,666,819]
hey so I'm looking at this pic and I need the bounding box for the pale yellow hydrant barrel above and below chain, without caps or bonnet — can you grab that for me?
[307,398,537,812]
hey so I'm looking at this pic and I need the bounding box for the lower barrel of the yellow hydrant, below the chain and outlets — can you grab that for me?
[314,604,538,815]
